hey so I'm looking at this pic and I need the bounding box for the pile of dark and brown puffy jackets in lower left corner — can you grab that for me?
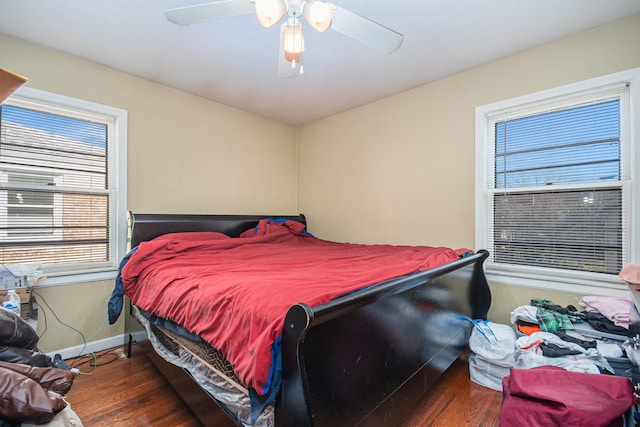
[0,309,82,427]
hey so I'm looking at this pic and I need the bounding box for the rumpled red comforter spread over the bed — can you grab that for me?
[121,220,469,394]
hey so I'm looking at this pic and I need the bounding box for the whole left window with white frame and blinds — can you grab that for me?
[0,88,127,284]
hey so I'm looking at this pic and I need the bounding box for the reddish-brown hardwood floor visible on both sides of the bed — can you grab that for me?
[67,348,502,427]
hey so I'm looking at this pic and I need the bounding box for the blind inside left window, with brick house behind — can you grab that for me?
[0,105,111,269]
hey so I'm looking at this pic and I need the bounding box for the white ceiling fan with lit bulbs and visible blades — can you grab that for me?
[165,0,404,77]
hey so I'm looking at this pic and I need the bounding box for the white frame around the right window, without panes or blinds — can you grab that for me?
[475,68,640,297]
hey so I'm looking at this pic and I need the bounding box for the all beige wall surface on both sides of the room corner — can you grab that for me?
[0,17,640,351]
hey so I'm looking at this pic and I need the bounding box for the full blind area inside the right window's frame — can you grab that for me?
[489,95,626,274]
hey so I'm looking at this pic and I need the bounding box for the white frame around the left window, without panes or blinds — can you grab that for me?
[4,86,128,286]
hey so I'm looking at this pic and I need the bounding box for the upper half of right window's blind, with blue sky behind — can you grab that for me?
[495,99,620,188]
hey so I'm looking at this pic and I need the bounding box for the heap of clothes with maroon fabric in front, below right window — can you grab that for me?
[500,296,634,427]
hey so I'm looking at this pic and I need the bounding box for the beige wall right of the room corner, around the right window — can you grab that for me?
[298,16,640,323]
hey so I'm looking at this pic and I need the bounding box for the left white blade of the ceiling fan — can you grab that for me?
[164,0,255,25]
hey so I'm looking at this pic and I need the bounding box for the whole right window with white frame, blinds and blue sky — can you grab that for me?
[476,69,640,295]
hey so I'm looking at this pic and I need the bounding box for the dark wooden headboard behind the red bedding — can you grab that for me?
[128,212,307,247]
